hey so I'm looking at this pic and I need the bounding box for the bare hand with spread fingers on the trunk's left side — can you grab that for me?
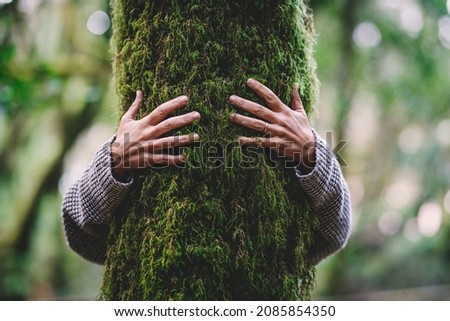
[111,91,200,181]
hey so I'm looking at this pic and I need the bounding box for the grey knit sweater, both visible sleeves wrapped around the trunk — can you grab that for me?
[62,134,351,264]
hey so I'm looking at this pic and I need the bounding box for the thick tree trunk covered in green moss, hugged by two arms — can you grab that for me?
[101,0,317,300]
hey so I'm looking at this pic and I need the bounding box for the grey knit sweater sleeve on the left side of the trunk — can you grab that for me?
[62,137,133,264]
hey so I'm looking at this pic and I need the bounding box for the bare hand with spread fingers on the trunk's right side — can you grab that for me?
[228,79,316,171]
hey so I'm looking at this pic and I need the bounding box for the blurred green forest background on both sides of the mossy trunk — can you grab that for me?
[0,0,450,300]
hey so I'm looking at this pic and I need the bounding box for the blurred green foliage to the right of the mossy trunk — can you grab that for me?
[314,0,450,300]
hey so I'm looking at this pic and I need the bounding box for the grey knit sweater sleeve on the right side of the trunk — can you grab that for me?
[296,132,351,264]
